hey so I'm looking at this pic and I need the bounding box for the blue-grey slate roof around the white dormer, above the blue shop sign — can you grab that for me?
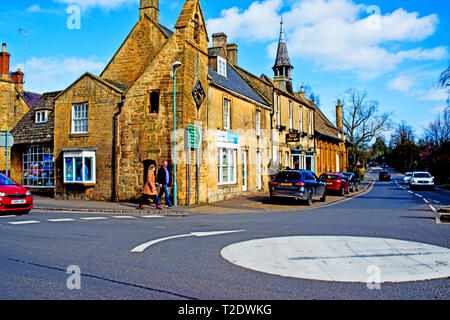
[209,64,269,106]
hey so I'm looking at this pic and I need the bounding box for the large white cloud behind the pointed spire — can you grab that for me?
[207,0,448,77]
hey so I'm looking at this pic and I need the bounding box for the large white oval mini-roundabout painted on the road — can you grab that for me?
[221,236,450,284]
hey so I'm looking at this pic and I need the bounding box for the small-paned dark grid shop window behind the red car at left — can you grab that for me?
[22,145,55,188]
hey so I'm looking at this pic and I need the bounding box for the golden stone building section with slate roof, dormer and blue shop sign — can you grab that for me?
[204,33,272,202]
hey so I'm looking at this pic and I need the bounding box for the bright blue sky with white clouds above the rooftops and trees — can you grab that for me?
[0,0,450,136]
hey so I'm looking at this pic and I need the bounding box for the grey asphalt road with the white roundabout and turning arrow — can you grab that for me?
[0,171,450,300]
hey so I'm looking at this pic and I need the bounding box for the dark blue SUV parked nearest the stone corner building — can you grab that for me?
[270,170,327,206]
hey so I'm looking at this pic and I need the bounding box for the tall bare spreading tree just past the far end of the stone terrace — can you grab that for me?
[341,89,391,170]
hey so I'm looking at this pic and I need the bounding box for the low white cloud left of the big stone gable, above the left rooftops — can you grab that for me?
[16,56,105,93]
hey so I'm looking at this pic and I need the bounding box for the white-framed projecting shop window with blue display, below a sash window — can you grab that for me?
[64,151,95,183]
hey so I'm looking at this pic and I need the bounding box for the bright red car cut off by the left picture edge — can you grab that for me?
[0,174,33,214]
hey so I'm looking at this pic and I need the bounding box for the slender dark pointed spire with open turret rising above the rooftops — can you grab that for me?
[273,17,294,92]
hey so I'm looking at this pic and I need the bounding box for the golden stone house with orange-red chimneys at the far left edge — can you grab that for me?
[0,43,40,171]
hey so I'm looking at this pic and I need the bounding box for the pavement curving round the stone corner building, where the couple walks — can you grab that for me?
[33,171,374,216]
